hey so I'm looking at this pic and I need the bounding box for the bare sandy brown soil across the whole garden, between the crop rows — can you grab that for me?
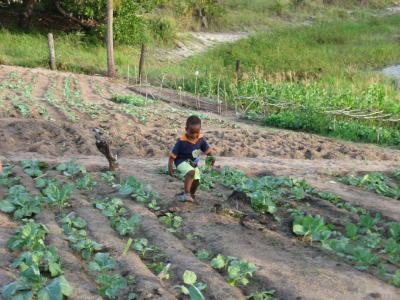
[0,66,400,300]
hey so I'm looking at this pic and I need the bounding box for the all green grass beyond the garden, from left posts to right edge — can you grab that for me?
[0,6,400,145]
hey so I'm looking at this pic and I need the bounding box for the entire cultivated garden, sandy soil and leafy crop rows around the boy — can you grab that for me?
[0,62,400,300]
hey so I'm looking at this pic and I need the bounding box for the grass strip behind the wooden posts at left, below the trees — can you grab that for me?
[0,29,161,76]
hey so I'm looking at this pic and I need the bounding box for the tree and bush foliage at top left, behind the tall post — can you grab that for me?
[0,0,222,44]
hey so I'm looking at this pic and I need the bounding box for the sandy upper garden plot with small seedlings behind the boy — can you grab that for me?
[0,66,400,160]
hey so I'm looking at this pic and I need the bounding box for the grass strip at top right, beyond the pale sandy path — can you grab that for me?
[211,0,397,30]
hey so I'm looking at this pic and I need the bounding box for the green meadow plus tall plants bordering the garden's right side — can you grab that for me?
[155,15,400,145]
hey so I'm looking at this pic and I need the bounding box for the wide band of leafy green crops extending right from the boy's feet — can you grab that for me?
[199,167,400,284]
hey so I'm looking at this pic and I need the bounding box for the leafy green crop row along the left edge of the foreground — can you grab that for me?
[0,161,72,299]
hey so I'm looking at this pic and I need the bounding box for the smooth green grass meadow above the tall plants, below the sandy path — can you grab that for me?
[162,15,400,84]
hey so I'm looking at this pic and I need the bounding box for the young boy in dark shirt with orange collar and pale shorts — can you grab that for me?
[168,116,215,202]
